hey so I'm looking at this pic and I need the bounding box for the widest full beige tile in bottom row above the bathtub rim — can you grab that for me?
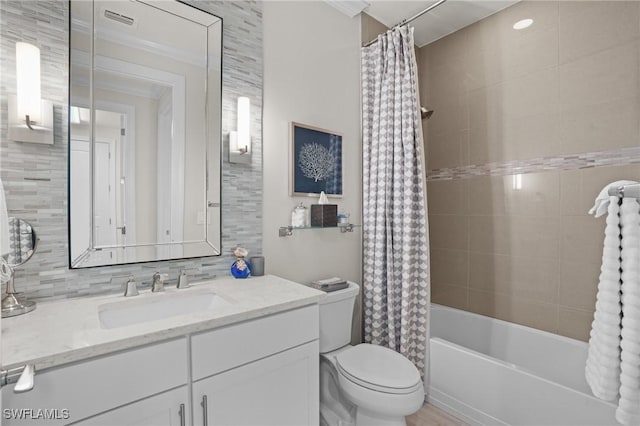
[469,289,558,333]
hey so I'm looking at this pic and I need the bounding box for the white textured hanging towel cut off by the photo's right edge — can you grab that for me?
[616,198,640,425]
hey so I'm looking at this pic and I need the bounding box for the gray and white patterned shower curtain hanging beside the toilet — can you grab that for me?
[362,26,430,374]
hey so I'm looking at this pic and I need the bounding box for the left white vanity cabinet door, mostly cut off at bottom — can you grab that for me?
[74,386,191,426]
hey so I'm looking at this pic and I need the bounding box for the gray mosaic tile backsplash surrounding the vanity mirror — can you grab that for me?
[0,0,262,300]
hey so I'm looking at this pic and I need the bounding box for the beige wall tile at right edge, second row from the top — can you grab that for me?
[559,41,639,110]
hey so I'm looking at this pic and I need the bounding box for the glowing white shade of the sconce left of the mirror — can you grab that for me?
[16,42,42,124]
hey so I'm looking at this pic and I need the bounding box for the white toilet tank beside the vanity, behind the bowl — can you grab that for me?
[319,282,360,353]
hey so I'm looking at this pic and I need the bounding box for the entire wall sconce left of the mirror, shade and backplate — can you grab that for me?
[8,42,53,144]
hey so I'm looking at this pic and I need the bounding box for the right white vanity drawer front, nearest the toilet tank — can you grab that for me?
[191,305,318,380]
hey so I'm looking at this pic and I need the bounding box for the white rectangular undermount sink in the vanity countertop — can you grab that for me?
[98,293,231,329]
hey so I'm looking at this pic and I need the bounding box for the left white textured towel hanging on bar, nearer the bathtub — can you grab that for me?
[585,195,622,401]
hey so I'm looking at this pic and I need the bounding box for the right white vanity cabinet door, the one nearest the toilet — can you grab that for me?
[193,340,319,426]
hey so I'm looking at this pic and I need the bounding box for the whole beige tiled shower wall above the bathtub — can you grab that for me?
[420,1,640,340]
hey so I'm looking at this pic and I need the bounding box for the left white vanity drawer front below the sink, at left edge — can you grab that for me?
[2,338,188,426]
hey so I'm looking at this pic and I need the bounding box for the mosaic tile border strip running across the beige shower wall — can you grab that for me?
[427,146,640,180]
